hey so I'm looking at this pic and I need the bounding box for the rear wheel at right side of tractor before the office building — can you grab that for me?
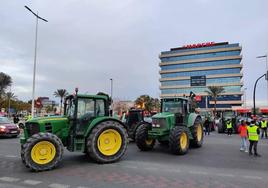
[190,118,204,148]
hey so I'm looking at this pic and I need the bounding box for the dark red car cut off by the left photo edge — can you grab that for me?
[0,117,20,137]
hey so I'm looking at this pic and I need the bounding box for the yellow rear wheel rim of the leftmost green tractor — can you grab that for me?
[98,129,122,156]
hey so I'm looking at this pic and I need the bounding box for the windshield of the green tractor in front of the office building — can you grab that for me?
[162,99,183,113]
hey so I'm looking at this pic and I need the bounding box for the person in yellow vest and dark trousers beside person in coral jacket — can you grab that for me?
[247,120,261,157]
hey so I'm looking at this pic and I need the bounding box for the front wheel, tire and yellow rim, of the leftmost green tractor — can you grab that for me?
[21,133,63,172]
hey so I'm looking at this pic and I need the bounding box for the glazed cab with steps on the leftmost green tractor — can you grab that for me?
[64,94,109,151]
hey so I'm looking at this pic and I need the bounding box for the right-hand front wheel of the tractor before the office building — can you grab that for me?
[169,126,189,155]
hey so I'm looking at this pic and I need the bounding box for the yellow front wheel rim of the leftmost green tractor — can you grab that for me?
[31,141,56,165]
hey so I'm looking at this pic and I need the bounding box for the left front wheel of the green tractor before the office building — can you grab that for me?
[135,123,155,151]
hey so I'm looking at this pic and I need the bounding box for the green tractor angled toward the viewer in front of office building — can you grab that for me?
[136,97,203,155]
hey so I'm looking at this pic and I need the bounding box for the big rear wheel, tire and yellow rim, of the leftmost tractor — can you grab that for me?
[87,120,128,163]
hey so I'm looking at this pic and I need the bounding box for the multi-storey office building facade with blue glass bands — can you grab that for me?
[160,42,242,109]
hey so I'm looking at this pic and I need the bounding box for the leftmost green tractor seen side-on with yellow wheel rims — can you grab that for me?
[20,90,128,171]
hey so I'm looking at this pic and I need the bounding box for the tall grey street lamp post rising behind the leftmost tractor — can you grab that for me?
[24,6,48,117]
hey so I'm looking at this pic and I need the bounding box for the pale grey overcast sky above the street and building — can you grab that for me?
[0,0,268,104]
